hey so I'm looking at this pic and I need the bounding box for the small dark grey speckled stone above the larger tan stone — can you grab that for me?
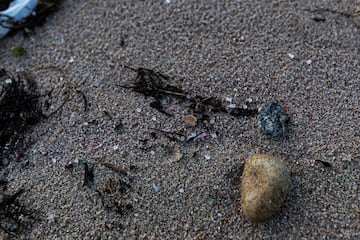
[257,99,289,137]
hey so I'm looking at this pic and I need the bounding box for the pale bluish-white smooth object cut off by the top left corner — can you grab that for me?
[0,0,37,38]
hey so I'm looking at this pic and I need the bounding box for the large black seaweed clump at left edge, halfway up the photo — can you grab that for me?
[0,69,43,166]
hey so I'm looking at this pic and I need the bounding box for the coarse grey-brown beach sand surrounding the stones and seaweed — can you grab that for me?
[0,0,360,239]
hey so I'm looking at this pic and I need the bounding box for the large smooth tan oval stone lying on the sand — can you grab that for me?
[241,154,291,222]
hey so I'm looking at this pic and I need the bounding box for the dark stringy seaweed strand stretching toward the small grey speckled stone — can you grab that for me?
[122,66,257,120]
